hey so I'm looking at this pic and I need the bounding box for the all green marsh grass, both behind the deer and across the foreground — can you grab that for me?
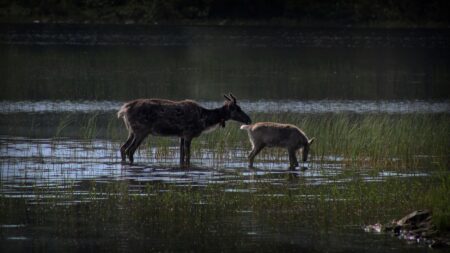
[0,113,450,249]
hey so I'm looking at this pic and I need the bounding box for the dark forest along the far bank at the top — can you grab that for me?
[0,0,450,27]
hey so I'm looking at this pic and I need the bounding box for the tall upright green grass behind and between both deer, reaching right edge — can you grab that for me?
[65,112,450,170]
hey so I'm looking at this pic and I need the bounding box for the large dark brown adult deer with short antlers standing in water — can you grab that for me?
[117,93,251,166]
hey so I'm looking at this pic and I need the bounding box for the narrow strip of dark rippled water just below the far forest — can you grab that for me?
[0,23,450,50]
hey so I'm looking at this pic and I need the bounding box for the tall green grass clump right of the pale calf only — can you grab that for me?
[246,113,450,167]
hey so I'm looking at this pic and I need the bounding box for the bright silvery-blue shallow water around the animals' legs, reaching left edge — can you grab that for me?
[0,137,428,190]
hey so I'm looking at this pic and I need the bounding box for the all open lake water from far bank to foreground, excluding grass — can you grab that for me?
[0,25,450,252]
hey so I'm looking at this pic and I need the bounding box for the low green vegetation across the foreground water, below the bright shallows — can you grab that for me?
[0,166,450,248]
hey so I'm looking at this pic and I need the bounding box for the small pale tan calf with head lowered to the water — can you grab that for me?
[241,122,314,169]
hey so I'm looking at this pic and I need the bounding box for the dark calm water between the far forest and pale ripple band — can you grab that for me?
[0,25,450,101]
